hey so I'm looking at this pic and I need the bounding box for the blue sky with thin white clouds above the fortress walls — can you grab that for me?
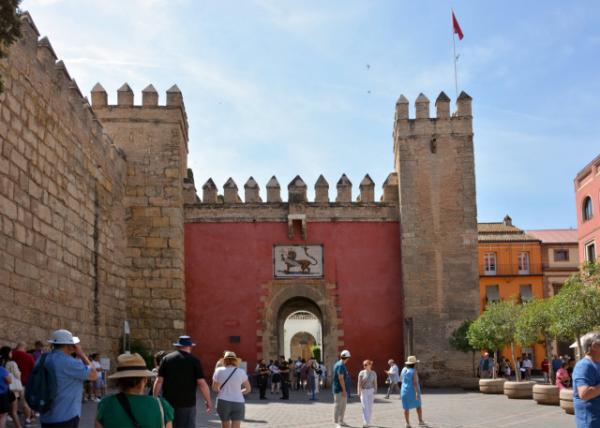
[22,0,600,229]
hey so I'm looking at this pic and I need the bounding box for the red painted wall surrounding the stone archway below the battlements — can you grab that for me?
[185,222,403,374]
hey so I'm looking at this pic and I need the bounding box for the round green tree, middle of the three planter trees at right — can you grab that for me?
[515,297,555,379]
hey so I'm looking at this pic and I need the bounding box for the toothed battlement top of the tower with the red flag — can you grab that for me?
[393,91,473,142]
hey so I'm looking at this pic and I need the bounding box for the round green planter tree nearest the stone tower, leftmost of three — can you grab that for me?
[467,300,521,380]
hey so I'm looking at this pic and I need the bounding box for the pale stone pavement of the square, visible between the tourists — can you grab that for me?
[9,390,575,428]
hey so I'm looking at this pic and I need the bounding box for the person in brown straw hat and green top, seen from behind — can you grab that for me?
[96,354,174,428]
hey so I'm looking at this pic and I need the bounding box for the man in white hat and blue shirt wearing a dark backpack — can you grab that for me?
[37,330,98,428]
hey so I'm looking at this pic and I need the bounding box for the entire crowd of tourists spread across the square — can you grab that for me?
[0,330,600,428]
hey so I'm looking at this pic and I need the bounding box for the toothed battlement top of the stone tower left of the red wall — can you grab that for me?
[91,83,189,148]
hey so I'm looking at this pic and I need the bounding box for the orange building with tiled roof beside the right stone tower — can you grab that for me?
[478,216,544,368]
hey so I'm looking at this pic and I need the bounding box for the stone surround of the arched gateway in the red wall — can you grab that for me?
[257,280,344,367]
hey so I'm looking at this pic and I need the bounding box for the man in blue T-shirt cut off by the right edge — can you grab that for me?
[573,332,600,428]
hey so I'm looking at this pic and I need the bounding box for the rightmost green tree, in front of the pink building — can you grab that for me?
[550,263,600,357]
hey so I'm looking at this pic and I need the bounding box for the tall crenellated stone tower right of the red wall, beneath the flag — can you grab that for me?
[393,92,479,386]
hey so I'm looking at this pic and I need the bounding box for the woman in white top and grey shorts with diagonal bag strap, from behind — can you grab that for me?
[212,351,252,428]
